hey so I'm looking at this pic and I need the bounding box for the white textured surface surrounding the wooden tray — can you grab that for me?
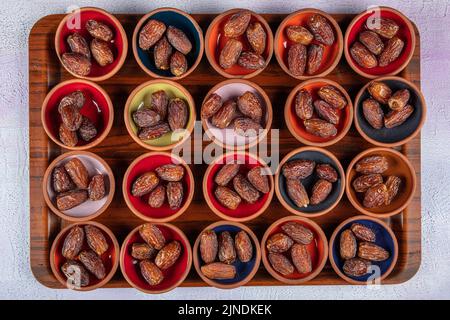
[0,0,450,299]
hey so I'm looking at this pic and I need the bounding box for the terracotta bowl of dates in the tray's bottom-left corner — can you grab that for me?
[50,221,119,291]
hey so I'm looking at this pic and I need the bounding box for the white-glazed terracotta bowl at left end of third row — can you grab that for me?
[42,151,115,222]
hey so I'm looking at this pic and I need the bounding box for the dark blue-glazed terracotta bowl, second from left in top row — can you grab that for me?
[132,8,204,80]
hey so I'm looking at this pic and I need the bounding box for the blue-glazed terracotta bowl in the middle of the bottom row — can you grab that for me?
[194,222,261,289]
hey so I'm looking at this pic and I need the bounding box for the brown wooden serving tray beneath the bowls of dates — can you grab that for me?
[29,14,421,288]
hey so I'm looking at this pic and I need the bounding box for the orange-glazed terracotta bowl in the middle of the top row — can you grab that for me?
[205,9,273,79]
